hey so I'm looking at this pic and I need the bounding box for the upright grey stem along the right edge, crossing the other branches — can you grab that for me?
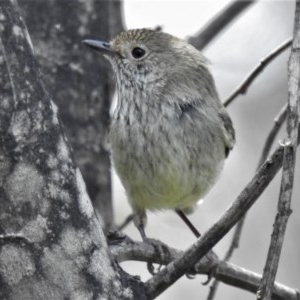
[257,0,300,300]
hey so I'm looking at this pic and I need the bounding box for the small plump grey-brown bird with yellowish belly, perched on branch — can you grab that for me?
[83,29,235,238]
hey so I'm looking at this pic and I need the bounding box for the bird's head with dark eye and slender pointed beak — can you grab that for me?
[83,29,205,85]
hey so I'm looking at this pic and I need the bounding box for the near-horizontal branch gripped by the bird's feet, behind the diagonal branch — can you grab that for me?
[110,237,299,300]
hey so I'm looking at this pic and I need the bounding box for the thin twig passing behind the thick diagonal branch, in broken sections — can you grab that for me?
[207,104,287,300]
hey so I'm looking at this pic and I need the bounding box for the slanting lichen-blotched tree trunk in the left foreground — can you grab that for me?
[0,0,143,300]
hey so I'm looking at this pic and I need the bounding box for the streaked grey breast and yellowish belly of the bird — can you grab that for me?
[110,99,224,209]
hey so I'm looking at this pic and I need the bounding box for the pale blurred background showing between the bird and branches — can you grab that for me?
[113,0,300,300]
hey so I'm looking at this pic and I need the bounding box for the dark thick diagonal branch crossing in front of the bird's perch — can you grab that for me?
[145,124,300,299]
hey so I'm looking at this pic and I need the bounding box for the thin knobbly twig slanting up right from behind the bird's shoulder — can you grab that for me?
[224,38,292,106]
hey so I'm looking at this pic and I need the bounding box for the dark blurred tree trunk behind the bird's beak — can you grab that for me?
[19,0,123,227]
